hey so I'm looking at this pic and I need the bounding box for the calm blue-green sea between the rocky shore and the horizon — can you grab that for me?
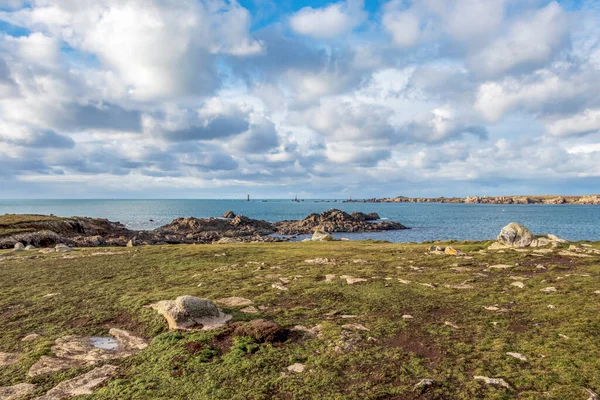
[0,200,600,242]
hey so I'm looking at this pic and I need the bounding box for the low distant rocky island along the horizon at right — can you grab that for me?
[344,194,600,204]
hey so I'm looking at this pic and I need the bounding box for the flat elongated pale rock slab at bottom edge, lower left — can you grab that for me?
[38,365,117,400]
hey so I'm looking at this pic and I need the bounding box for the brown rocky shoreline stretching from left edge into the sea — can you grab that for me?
[0,209,408,249]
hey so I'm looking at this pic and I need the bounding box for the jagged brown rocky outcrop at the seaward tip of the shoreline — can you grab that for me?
[275,209,407,235]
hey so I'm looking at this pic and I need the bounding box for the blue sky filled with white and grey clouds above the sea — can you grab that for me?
[0,0,600,198]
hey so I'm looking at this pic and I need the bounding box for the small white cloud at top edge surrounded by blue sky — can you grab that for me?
[290,0,366,39]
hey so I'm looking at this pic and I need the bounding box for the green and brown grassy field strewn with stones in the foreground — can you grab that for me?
[0,242,600,400]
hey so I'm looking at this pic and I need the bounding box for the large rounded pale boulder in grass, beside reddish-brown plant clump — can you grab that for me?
[149,296,231,330]
